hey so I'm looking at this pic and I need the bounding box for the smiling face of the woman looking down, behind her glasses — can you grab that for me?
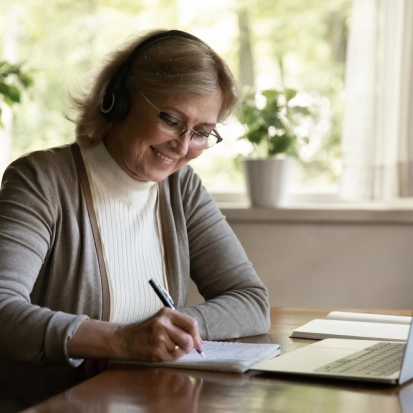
[103,94,222,182]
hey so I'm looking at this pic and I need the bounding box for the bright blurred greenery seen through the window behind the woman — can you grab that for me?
[0,0,352,192]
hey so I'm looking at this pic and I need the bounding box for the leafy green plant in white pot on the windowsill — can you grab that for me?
[240,89,311,207]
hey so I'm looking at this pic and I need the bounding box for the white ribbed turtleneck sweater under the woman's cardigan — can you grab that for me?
[81,141,168,323]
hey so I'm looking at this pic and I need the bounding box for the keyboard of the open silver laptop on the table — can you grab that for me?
[315,342,405,376]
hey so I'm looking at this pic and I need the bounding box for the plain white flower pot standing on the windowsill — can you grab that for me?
[242,158,291,208]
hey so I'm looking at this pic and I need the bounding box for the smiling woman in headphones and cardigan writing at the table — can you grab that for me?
[0,30,269,403]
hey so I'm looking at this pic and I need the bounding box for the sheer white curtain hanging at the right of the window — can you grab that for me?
[340,0,413,201]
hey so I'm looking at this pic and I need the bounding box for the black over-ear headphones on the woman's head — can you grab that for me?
[100,30,207,122]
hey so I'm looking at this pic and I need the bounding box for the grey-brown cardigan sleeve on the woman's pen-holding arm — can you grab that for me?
[0,157,88,366]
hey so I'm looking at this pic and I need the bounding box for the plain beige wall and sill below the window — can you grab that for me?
[187,209,413,309]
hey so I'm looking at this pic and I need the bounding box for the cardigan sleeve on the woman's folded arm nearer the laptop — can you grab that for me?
[174,168,270,340]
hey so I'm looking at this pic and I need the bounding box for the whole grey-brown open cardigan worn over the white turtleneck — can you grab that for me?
[0,144,269,366]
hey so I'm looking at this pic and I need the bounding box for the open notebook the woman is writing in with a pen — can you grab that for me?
[111,341,280,373]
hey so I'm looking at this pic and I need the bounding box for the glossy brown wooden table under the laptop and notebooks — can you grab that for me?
[24,308,413,413]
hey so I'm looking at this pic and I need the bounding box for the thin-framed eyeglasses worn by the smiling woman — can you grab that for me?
[141,93,223,150]
